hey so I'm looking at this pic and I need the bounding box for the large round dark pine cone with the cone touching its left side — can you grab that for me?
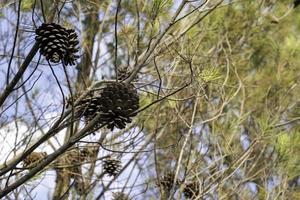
[79,82,139,130]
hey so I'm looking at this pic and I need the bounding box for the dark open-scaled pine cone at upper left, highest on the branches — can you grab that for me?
[35,23,79,66]
